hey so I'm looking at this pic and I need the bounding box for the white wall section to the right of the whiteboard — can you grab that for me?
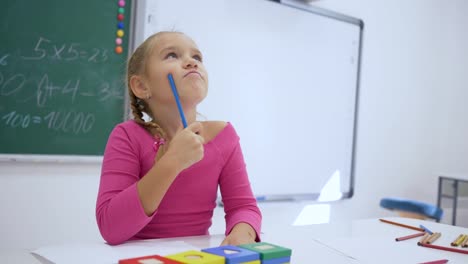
[308,0,468,226]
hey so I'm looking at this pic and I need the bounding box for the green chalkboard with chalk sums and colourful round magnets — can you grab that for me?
[0,0,132,155]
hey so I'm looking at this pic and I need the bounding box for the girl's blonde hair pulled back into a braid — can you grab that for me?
[127,31,180,139]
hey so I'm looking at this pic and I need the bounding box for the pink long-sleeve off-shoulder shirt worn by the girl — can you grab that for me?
[96,120,262,244]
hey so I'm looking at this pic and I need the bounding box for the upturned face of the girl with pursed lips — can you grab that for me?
[145,33,208,107]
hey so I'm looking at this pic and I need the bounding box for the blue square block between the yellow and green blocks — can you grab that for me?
[202,246,260,264]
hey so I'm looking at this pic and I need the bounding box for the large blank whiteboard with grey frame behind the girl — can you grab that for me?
[140,0,362,198]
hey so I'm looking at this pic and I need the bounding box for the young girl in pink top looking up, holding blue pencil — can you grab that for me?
[96,32,262,245]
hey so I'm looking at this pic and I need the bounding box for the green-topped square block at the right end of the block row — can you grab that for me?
[239,242,292,264]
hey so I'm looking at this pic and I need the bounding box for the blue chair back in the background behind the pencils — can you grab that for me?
[380,198,444,220]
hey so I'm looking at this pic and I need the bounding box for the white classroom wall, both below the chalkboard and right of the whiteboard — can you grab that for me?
[0,0,468,248]
